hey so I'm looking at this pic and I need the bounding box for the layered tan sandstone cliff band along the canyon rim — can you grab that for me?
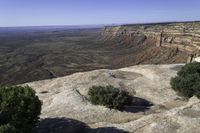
[102,22,200,59]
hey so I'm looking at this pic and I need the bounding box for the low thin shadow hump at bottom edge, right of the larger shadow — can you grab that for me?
[88,127,128,133]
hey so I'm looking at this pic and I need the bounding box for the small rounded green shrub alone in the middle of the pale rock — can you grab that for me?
[88,86,132,110]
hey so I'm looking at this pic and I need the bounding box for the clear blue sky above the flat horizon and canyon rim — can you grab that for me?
[0,0,200,27]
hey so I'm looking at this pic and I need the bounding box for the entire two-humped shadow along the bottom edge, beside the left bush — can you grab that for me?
[33,118,128,133]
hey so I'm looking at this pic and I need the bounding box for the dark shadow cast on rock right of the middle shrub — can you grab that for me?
[123,97,153,113]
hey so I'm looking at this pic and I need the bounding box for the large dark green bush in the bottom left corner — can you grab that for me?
[0,86,42,133]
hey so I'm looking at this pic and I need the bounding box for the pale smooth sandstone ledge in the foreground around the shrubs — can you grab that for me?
[24,64,200,133]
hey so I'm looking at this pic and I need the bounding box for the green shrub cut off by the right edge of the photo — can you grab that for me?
[170,62,200,98]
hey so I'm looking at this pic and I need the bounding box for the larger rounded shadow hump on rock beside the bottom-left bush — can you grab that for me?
[33,118,88,133]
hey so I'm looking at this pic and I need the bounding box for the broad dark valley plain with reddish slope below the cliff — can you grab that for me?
[0,26,188,85]
